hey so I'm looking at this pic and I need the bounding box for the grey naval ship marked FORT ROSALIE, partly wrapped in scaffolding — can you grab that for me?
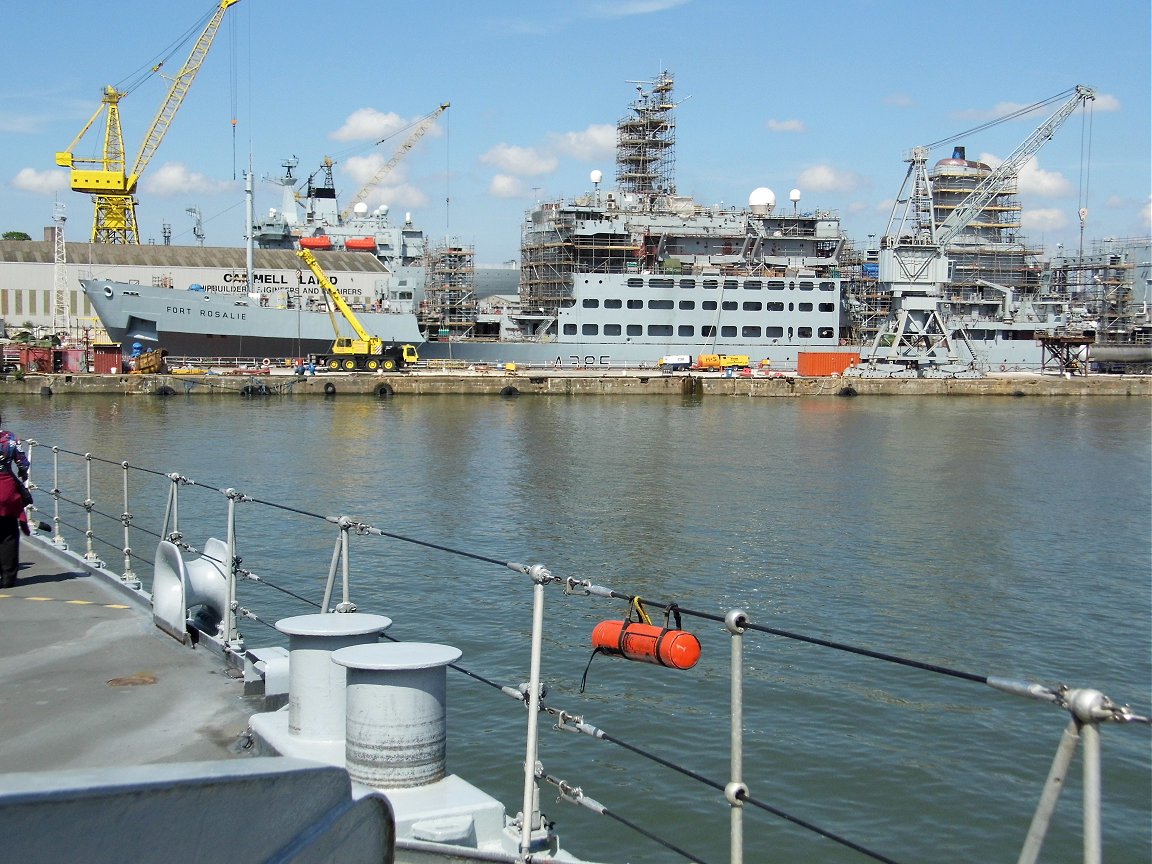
[82,73,1147,371]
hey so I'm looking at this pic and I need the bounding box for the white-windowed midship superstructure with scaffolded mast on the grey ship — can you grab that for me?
[474,73,844,362]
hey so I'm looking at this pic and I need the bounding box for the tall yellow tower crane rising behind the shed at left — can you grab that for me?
[56,0,240,244]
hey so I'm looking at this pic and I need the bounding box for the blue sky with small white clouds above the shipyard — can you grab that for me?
[0,0,1152,264]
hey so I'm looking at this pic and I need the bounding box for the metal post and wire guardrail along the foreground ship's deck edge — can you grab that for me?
[25,440,1152,864]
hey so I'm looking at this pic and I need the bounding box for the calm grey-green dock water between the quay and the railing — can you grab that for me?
[2,396,1152,864]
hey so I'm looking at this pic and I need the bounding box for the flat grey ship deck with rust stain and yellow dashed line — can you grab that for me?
[0,537,254,773]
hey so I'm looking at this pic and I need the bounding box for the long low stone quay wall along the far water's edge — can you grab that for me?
[0,372,1152,399]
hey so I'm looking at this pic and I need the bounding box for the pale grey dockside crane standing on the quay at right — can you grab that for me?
[862,84,1096,373]
